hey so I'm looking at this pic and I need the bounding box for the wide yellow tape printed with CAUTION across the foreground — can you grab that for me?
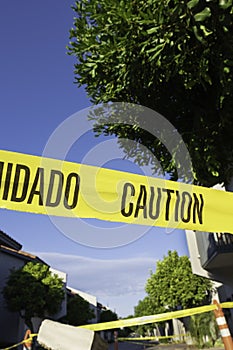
[0,151,233,233]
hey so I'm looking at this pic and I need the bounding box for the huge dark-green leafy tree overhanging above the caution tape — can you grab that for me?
[69,0,233,186]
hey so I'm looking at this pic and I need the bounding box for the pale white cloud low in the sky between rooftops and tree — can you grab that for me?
[36,252,156,316]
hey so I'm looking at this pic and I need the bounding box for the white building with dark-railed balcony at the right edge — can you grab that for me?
[186,185,233,335]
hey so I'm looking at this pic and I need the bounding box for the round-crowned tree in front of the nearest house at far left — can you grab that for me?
[3,262,64,332]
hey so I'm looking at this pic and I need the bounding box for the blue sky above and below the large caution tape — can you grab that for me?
[0,0,187,316]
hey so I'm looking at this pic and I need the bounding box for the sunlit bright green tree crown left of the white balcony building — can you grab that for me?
[146,251,212,310]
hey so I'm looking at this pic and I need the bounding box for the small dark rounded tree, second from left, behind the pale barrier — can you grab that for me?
[66,295,95,326]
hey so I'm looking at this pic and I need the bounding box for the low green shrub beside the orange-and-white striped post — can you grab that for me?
[189,312,219,348]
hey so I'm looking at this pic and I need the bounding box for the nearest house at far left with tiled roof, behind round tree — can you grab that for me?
[0,230,66,345]
